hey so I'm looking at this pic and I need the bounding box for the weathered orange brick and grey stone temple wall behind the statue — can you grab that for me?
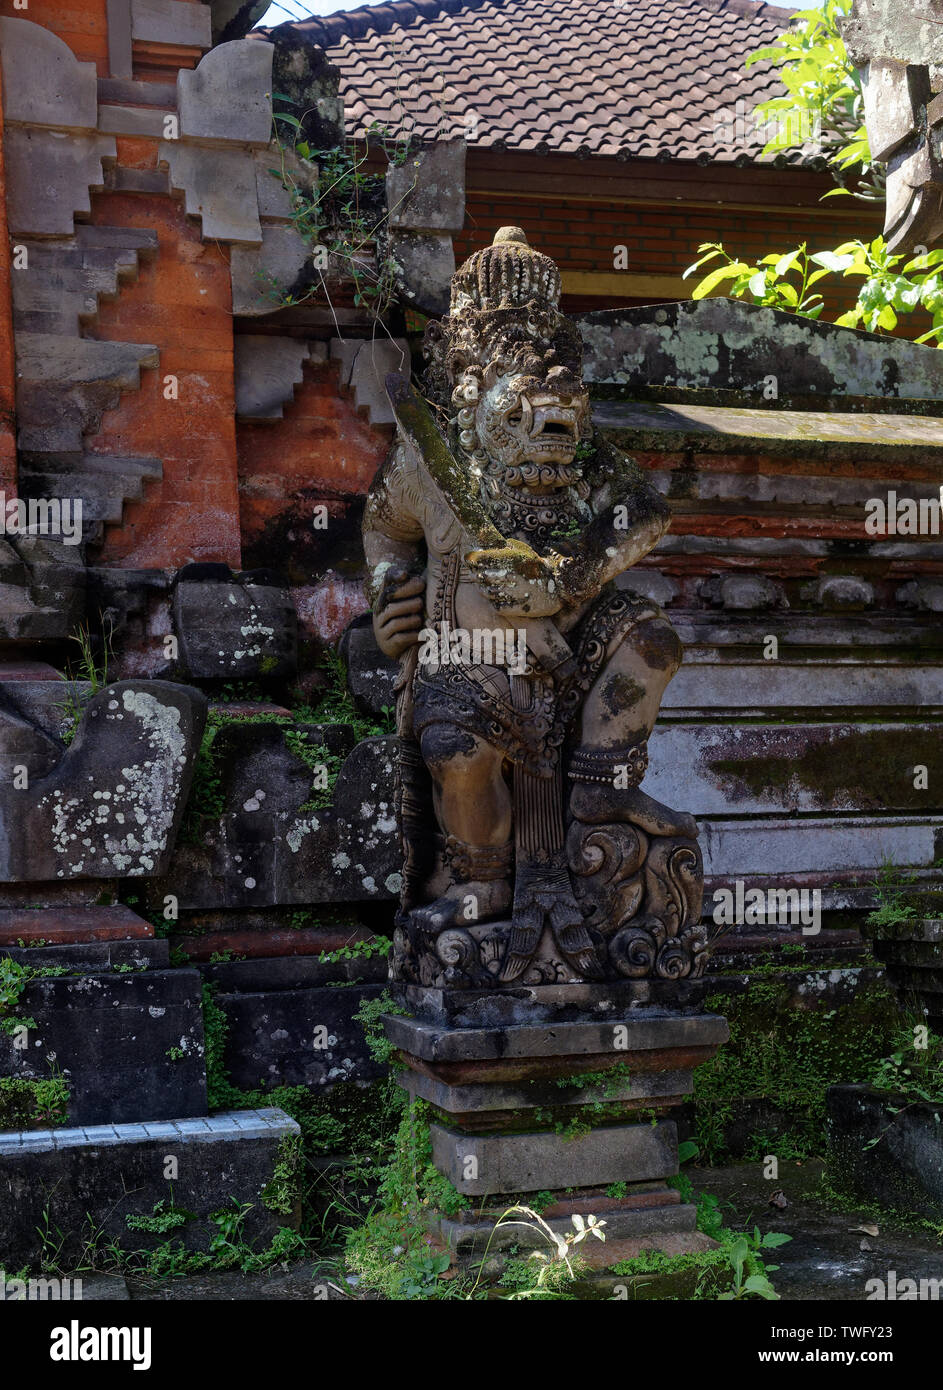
[0,0,943,1254]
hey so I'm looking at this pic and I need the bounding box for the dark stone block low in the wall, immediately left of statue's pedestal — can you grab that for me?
[216,984,385,1090]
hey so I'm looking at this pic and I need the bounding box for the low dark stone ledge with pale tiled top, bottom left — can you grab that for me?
[0,1109,300,1270]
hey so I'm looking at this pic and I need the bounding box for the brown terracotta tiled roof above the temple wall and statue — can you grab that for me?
[273,0,797,161]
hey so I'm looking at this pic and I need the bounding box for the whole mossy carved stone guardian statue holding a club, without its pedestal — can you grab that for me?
[364,227,705,988]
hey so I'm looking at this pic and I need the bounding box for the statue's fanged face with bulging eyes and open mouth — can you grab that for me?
[474,377,590,487]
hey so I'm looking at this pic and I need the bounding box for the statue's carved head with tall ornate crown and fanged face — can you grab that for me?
[426,227,591,491]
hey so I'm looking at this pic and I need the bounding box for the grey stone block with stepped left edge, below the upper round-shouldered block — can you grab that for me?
[160,141,263,244]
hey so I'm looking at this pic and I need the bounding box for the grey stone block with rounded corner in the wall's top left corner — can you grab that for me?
[0,17,99,130]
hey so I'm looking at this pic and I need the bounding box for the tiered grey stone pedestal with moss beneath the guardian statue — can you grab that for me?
[384,981,729,1268]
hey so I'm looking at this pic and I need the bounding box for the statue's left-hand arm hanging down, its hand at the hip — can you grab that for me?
[363,449,426,657]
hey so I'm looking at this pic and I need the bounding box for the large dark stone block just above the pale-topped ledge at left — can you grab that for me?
[0,969,206,1125]
